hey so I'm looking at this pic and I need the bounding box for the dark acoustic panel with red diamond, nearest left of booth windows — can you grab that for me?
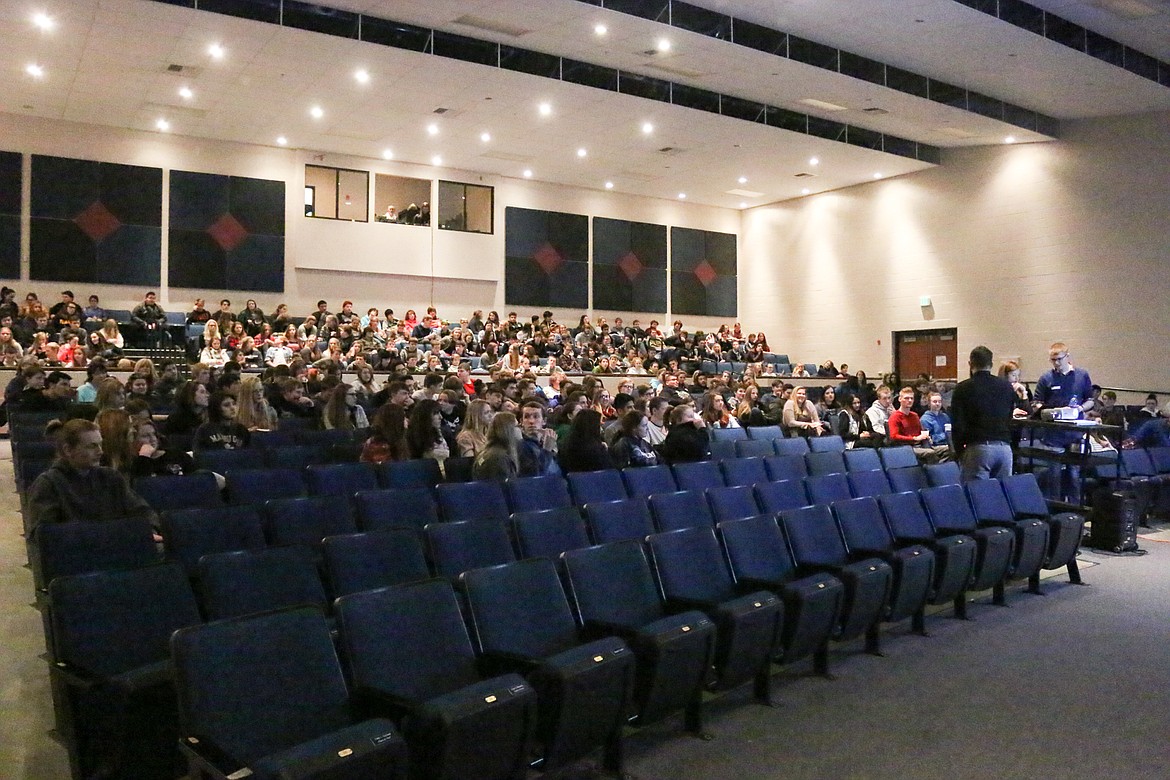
[167,171,284,292]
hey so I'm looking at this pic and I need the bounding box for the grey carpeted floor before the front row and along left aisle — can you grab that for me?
[0,442,1170,780]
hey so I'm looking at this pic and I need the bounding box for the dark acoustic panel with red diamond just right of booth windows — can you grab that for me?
[504,207,589,309]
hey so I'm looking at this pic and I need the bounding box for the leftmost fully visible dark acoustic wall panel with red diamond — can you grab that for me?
[29,154,163,287]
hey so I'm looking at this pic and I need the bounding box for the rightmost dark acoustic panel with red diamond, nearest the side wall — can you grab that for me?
[670,228,738,317]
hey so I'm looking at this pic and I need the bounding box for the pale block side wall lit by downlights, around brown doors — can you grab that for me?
[739,113,1170,388]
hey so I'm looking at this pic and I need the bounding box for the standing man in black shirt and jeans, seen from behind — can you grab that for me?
[951,346,1016,482]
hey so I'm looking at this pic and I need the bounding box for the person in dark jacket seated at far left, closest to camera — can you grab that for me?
[26,420,157,541]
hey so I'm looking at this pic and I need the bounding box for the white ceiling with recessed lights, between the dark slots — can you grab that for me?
[0,0,1170,208]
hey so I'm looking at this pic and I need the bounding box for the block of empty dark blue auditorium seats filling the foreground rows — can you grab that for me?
[27,420,1152,778]
